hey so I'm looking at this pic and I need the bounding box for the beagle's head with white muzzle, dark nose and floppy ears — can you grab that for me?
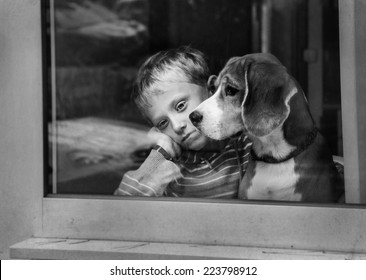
[190,53,305,140]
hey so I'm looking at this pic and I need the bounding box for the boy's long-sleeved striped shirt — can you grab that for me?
[115,135,251,198]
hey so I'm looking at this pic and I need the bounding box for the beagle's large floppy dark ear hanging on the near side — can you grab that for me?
[242,58,289,137]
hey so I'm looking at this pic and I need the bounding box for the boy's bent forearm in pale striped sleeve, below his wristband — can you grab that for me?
[114,149,182,196]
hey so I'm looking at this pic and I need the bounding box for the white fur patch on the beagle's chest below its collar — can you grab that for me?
[247,159,302,201]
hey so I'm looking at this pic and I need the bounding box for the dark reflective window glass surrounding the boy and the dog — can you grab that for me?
[44,0,343,201]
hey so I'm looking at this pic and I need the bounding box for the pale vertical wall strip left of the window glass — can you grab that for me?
[0,0,43,259]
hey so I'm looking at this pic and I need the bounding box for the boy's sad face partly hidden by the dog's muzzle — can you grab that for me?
[147,82,209,151]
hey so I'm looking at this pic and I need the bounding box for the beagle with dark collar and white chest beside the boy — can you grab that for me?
[190,53,344,202]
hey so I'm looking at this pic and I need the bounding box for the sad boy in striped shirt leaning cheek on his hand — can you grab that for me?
[114,47,251,198]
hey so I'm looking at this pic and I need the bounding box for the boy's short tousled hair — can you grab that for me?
[132,46,210,116]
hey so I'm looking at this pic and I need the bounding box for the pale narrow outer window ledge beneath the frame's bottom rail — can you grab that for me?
[10,238,366,260]
